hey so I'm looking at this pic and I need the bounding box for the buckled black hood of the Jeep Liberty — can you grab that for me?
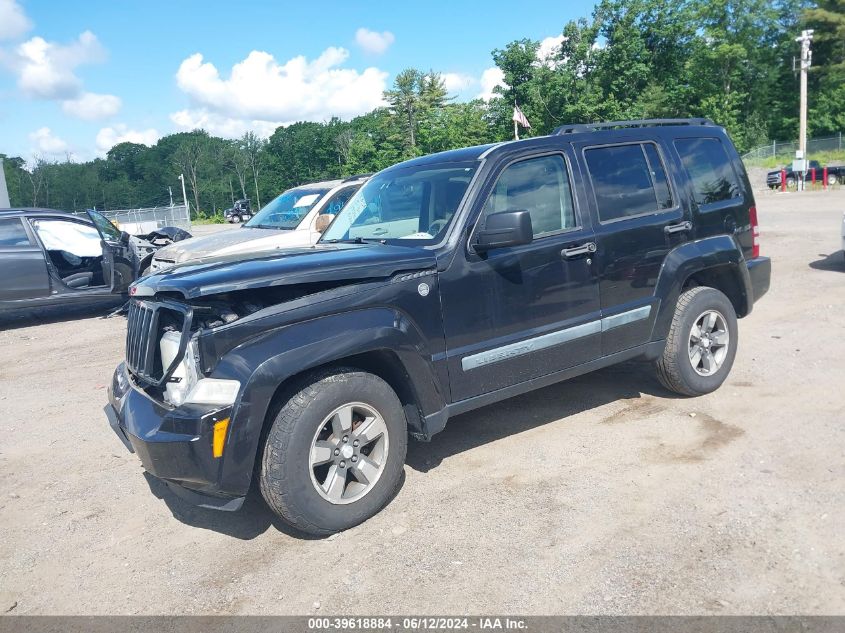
[134,243,437,299]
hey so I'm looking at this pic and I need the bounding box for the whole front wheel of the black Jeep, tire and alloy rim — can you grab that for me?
[259,369,408,535]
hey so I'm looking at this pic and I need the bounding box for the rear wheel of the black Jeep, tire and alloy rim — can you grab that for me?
[657,286,738,396]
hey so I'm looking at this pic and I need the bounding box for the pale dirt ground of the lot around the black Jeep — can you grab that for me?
[0,191,845,615]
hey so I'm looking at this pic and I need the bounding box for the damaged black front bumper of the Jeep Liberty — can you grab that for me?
[105,363,244,510]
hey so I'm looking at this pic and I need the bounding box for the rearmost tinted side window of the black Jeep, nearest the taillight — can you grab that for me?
[675,138,740,205]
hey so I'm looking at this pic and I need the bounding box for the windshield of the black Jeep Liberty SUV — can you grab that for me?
[321,162,477,244]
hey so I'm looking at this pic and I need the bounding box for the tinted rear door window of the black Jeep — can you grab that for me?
[584,143,673,222]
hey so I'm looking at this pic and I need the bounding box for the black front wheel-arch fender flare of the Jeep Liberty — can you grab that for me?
[212,307,445,494]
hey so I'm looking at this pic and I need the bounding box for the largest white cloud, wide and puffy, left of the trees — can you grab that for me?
[171,47,387,136]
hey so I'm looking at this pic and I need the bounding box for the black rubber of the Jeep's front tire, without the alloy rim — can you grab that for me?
[259,368,408,536]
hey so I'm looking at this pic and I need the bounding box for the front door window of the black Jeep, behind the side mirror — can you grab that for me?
[484,156,576,237]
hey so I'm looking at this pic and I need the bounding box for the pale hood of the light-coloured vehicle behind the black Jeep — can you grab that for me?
[155,228,311,264]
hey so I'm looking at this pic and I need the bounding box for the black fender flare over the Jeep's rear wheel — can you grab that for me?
[651,235,754,340]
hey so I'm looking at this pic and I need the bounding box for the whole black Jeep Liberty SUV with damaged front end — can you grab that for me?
[106,119,771,534]
